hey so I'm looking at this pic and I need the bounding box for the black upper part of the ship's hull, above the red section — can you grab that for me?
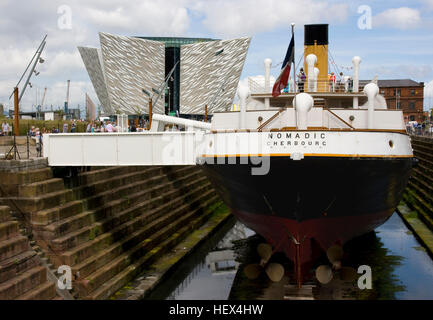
[203,157,412,222]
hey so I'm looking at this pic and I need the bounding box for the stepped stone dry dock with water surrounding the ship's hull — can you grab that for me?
[0,136,433,300]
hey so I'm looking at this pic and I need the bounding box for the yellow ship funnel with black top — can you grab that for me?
[304,24,328,92]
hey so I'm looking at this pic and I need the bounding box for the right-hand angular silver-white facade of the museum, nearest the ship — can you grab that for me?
[180,38,251,114]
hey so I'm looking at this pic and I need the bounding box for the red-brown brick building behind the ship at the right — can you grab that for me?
[372,79,427,122]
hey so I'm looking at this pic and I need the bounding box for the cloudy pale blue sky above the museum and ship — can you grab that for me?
[0,0,433,111]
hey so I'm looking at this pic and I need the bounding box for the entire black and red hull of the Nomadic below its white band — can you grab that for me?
[199,157,412,278]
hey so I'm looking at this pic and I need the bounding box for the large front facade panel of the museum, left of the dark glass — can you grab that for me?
[99,33,165,114]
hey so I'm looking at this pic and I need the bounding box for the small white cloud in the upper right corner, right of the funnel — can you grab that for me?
[373,7,422,30]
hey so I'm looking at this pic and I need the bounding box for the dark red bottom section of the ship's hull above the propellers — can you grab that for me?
[232,210,393,285]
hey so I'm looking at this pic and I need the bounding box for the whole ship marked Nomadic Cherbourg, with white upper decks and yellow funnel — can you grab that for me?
[198,24,414,286]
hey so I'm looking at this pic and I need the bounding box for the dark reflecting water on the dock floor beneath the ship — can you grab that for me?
[146,213,433,300]
